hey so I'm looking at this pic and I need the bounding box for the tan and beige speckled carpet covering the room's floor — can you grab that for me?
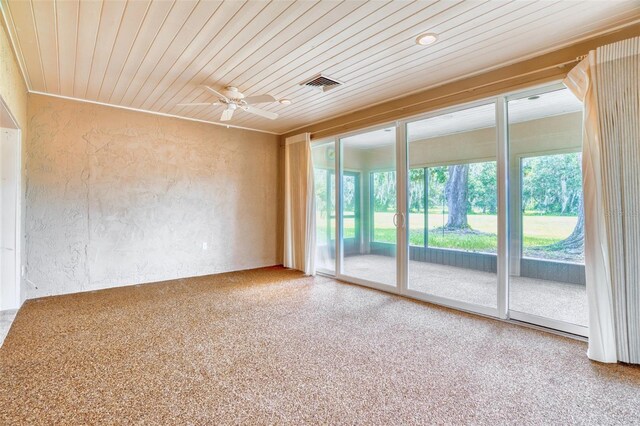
[0,268,640,425]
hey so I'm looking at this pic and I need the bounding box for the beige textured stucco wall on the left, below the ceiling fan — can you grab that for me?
[26,94,279,297]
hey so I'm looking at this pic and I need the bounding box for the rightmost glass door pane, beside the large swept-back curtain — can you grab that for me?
[507,89,588,334]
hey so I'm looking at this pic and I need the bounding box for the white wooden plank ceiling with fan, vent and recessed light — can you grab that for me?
[0,0,640,133]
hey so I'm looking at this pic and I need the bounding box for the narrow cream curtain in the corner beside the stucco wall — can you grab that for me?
[283,133,316,275]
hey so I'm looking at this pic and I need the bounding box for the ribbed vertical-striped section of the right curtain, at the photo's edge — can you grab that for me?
[596,37,640,363]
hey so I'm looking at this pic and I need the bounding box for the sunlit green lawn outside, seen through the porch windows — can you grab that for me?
[317,210,577,252]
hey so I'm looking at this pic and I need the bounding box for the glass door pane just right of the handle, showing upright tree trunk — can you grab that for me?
[406,103,498,308]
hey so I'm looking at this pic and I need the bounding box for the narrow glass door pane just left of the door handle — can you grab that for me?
[340,127,397,287]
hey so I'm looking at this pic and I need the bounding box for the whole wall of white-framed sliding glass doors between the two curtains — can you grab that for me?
[313,85,588,335]
